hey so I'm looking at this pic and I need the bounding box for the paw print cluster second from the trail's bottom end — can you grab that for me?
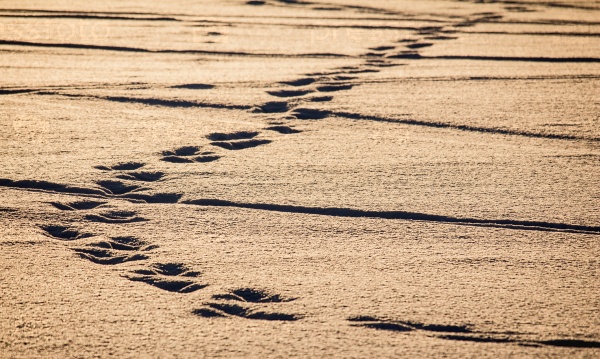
[127,263,207,293]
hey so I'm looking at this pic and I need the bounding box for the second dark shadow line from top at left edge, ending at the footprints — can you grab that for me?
[0,40,353,58]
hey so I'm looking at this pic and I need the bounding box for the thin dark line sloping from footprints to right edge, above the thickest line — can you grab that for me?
[331,112,600,141]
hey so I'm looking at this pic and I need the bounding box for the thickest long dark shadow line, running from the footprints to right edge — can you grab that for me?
[181,199,600,235]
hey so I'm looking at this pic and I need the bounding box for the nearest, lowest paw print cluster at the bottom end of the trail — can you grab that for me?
[193,288,302,321]
